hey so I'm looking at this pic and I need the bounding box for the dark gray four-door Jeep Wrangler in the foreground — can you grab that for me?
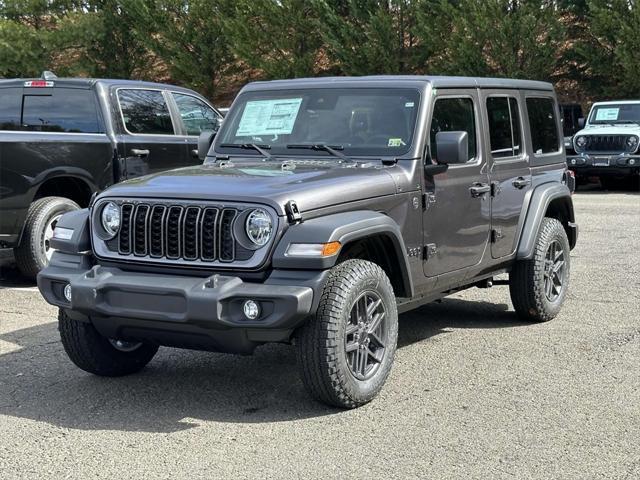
[38,76,578,408]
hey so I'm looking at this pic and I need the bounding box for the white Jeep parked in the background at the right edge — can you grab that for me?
[567,100,640,189]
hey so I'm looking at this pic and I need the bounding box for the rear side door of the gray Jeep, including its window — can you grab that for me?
[481,90,531,258]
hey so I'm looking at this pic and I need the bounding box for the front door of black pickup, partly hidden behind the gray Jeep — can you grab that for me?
[170,92,222,164]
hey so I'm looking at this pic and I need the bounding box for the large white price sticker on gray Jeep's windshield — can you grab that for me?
[236,98,302,137]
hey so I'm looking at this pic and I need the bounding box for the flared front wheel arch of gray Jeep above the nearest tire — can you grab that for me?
[273,210,414,297]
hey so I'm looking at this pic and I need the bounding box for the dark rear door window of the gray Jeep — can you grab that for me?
[487,97,522,158]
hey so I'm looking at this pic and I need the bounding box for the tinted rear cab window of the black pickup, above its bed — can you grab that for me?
[22,88,104,133]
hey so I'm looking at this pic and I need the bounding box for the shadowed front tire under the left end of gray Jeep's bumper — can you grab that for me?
[58,310,158,377]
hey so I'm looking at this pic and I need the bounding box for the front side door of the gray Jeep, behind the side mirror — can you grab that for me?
[423,89,491,277]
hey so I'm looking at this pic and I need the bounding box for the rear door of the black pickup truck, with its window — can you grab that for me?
[116,87,189,178]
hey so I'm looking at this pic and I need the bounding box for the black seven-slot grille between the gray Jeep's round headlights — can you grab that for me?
[117,203,238,262]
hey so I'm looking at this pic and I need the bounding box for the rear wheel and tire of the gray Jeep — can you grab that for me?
[509,218,571,322]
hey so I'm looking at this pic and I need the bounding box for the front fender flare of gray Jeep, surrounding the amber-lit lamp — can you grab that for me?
[272,210,414,296]
